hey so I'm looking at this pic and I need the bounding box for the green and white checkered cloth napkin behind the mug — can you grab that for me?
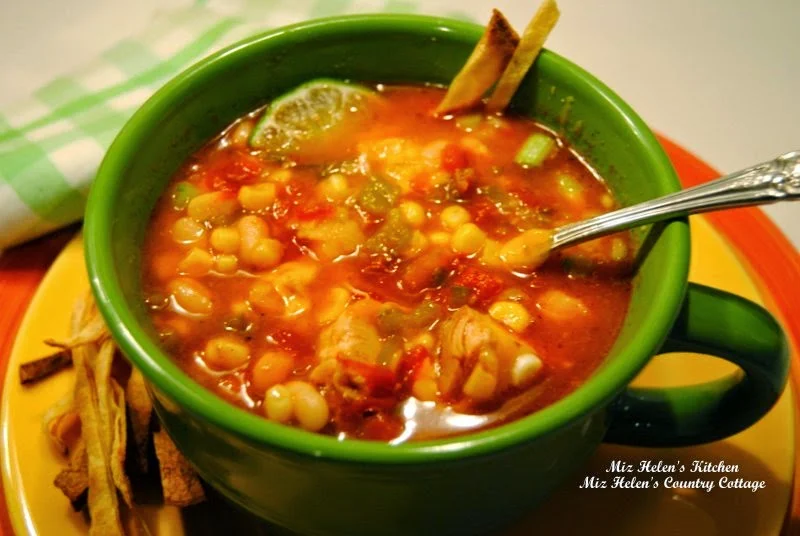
[0,0,476,250]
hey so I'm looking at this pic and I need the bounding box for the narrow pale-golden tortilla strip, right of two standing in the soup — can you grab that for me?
[486,0,561,113]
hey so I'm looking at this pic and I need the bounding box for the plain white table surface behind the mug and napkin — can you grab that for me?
[0,0,800,249]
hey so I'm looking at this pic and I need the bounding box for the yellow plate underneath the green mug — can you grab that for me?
[0,218,794,536]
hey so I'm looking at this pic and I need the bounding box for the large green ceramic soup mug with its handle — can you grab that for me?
[85,16,788,535]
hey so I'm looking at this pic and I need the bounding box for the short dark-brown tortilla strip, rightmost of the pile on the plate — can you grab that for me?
[153,429,206,508]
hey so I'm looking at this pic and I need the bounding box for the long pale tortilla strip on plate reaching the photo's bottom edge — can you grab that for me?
[72,344,124,536]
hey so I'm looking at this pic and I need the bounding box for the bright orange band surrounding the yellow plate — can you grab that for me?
[0,137,800,536]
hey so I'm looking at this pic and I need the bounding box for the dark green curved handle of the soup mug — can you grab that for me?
[603,283,789,447]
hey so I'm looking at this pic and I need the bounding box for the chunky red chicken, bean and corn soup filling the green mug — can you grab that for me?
[143,81,633,443]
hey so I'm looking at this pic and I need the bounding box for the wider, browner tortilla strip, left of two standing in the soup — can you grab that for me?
[436,9,519,115]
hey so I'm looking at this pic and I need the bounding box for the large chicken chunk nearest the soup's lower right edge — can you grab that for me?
[439,306,538,402]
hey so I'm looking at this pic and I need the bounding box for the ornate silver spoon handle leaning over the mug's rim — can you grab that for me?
[551,151,800,250]
